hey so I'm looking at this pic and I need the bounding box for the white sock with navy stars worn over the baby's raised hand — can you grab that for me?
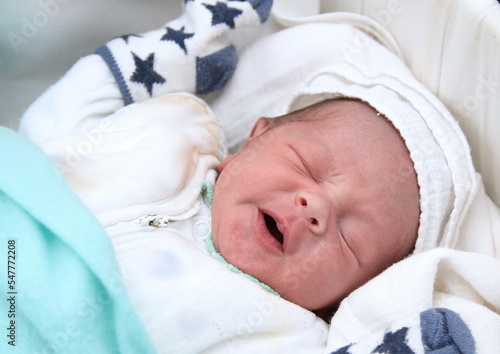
[96,0,272,105]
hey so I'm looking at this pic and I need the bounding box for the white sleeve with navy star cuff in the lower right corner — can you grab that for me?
[327,249,500,353]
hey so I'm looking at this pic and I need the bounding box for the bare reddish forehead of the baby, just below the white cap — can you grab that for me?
[268,99,411,174]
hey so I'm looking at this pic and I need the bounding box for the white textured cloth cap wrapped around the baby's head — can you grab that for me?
[290,31,475,252]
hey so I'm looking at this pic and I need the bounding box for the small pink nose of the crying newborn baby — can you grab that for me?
[296,191,331,235]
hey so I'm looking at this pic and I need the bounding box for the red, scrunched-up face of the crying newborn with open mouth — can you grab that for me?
[212,101,420,310]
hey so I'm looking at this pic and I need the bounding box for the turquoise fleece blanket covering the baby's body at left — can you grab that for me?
[0,127,155,354]
